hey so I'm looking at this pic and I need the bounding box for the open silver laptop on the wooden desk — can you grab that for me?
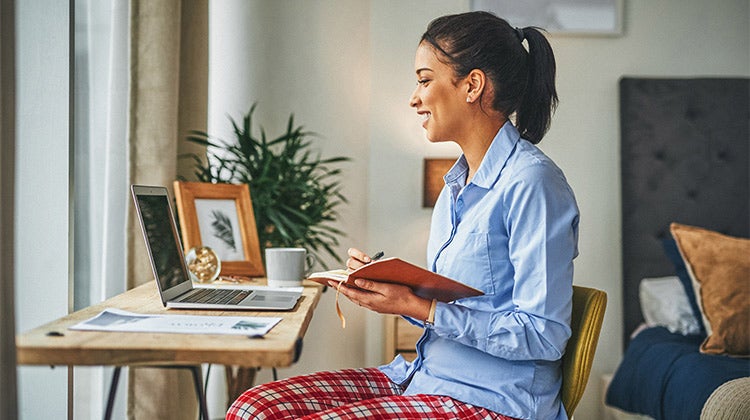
[130,185,302,310]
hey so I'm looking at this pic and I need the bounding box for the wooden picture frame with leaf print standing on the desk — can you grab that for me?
[173,181,265,277]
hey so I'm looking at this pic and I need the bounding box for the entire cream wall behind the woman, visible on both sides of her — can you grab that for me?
[210,0,750,419]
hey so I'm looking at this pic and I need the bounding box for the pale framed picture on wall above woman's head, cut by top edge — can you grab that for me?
[471,0,625,36]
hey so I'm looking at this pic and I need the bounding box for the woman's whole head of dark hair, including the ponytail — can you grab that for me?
[420,11,557,144]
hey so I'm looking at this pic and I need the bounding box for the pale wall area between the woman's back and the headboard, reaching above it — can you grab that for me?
[542,0,750,419]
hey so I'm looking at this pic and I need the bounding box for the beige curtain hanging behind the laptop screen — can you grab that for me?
[127,0,208,420]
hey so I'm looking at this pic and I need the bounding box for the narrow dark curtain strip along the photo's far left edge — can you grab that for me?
[0,0,18,419]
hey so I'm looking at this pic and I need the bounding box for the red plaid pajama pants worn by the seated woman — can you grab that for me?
[226,368,512,420]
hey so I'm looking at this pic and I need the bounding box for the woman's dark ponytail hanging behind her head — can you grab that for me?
[516,27,558,144]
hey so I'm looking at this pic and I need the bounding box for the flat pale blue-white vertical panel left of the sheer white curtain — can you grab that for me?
[15,0,72,419]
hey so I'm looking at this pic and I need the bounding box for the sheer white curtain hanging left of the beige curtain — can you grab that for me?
[73,0,129,418]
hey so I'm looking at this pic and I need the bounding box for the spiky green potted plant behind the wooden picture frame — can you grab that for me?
[188,104,350,269]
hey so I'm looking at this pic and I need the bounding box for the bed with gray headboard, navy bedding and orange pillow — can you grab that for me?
[605,77,750,420]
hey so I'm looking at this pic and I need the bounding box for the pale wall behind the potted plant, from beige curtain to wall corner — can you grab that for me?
[208,0,370,417]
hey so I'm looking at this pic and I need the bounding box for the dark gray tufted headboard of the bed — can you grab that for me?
[620,78,750,344]
